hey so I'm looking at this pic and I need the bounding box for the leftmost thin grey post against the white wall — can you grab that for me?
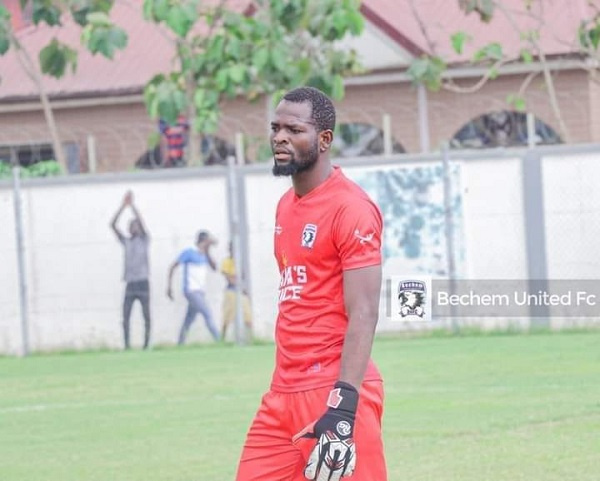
[11,159,29,356]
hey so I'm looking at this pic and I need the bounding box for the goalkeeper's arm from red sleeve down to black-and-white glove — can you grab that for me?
[294,203,382,481]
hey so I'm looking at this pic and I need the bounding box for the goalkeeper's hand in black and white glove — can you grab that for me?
[294,381,358,481]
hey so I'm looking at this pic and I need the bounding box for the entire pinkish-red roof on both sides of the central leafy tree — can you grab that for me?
[0,0,600,100]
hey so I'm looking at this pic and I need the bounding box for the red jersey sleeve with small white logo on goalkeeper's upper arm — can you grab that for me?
[333,195,383,270]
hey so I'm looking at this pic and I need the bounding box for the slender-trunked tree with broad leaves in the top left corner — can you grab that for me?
[0,0,127,172]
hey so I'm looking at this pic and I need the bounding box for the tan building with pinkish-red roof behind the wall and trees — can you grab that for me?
[0,0,600,172]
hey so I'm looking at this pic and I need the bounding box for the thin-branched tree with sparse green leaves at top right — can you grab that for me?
[407,0,600,139]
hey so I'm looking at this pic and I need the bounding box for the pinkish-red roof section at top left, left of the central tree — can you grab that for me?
[0,0,251,100]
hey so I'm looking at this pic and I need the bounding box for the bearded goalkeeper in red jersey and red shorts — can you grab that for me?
[237,87,387,481]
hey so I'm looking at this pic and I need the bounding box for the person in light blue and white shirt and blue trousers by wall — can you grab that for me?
[167,230,219,345]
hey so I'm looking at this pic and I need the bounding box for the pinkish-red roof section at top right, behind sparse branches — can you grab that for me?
[363,0,600,62]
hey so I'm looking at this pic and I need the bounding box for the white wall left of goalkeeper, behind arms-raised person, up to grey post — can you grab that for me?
[0,171,229,353]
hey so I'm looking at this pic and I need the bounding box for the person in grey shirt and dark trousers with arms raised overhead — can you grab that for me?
[110,191,150,349]
